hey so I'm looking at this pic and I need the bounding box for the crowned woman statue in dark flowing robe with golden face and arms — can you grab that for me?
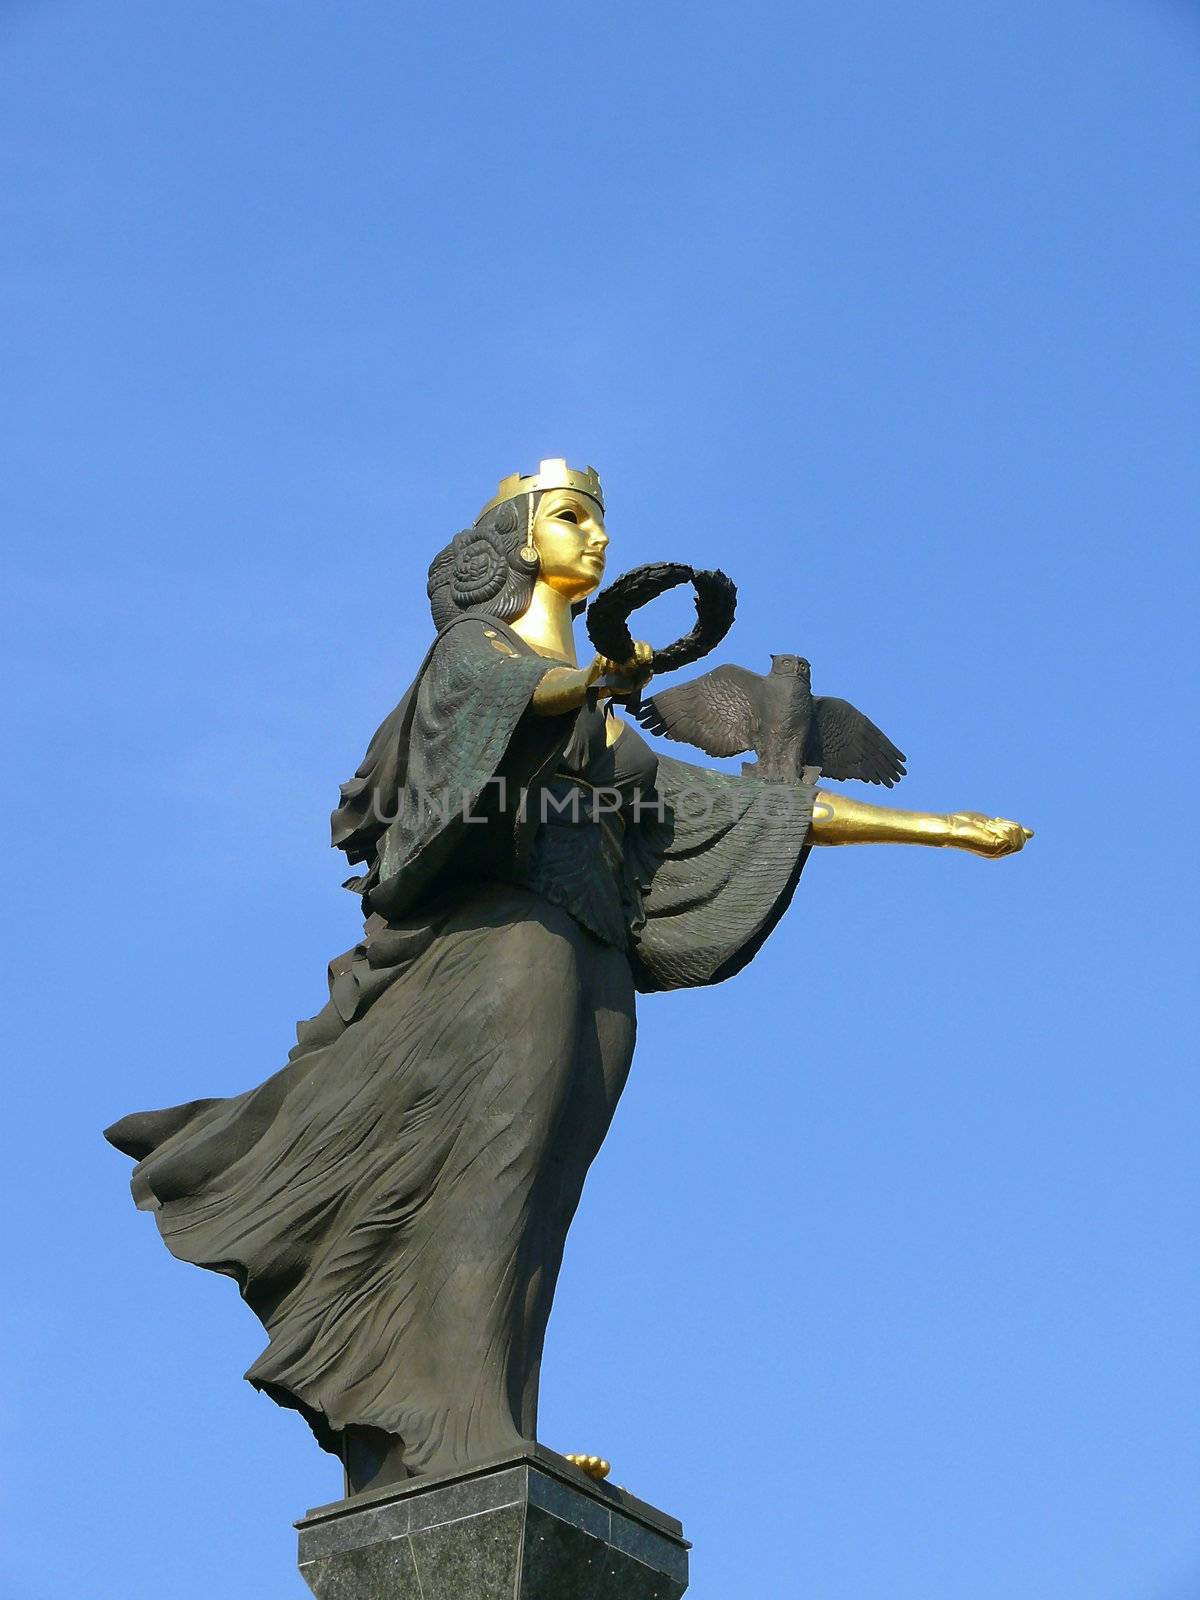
[107,461,1029,1490]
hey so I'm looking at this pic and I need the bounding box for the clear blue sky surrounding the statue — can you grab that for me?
[0,0,1200,1600]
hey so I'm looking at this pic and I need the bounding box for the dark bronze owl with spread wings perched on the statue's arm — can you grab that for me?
[635,656,904,789]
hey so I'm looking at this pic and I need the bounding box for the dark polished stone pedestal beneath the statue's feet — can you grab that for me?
[296,1445,690,1600]
